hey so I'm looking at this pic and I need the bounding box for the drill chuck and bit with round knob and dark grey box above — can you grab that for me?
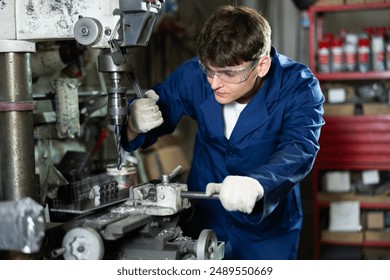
[75,0,164,170]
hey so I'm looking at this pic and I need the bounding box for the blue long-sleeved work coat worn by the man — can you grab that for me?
[124,48,324,259]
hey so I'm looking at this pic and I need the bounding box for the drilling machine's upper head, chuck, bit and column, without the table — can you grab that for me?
[0,0,164,203]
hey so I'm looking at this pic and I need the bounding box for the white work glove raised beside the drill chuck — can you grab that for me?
[128,90,164,133]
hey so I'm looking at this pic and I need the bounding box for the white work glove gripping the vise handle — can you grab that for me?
[206,176,264,214]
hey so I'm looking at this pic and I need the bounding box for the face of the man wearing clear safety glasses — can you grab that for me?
[204,60,260,105]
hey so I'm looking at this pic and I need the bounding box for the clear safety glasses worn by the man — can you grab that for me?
[199,59,259,84]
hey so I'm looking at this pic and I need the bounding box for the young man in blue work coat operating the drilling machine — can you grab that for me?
[122,6,324,259]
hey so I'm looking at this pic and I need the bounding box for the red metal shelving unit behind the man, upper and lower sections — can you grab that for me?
[308,2,390,259]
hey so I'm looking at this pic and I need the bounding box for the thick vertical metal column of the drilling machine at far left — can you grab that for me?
[0,52,37,200]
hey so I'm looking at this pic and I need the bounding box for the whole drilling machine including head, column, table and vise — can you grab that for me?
[0,0,224,259]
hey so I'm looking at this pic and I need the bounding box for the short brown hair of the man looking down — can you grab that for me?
[196,5,271,68]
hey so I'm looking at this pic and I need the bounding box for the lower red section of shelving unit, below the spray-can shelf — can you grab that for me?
[312,115,390,259]
